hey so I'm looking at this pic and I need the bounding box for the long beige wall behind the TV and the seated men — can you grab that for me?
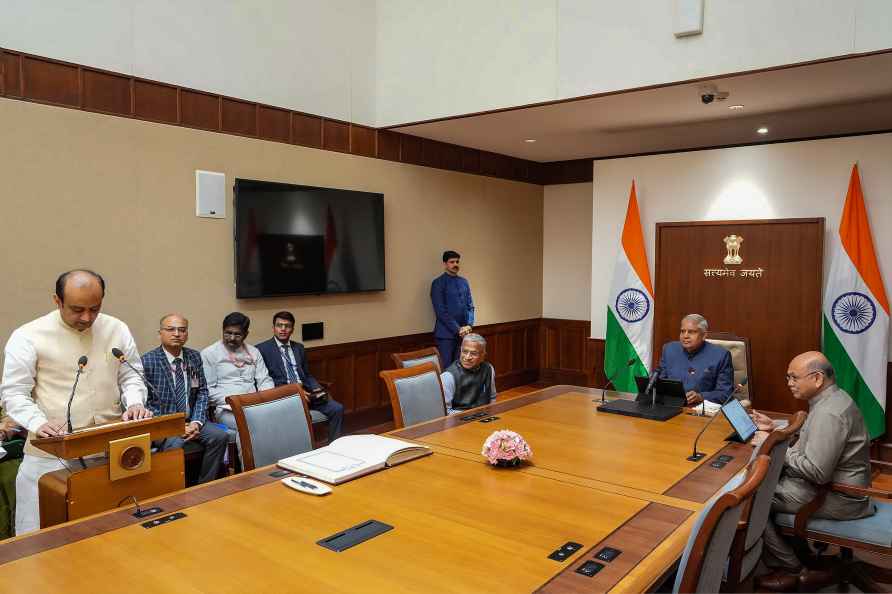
[0,99,543,350]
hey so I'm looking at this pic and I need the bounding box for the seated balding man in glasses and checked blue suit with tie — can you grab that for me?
[142,314,229,483]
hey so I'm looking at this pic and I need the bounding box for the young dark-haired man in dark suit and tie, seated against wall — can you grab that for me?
[254,311,344,442]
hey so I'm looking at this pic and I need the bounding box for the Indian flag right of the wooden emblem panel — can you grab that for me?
[824,165,889,438]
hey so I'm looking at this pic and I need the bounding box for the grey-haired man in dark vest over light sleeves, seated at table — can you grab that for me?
[440,333,496,415]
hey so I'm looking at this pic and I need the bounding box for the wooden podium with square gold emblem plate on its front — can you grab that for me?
[31,413,186,528]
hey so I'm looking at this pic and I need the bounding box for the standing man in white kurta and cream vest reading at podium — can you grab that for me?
[0,270,151,534]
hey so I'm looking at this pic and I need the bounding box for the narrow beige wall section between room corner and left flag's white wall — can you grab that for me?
[542,183,592,320]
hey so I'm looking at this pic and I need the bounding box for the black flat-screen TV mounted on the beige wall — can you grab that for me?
[235,179,384,299]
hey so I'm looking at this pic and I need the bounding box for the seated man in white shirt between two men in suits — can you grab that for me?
[201,311,275,429]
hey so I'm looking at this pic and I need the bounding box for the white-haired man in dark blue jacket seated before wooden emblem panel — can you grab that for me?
[660,314,734,406]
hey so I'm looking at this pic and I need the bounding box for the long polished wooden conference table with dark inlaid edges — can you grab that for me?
[0,386,752,593]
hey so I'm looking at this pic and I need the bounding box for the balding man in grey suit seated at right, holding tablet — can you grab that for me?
[752,352,875,592]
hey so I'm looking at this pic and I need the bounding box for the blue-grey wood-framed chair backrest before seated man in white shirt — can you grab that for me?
[226,384,315,470]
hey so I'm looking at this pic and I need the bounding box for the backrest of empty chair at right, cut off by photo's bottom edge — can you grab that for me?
[672,455,770,592]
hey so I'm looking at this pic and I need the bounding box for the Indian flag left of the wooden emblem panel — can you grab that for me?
[604,181,654,392]
